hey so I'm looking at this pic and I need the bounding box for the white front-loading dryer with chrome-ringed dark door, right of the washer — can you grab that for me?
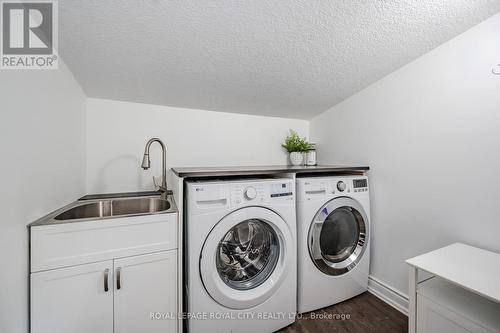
[297,176,370,313]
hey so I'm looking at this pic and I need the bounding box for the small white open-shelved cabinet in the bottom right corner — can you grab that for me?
[406,243,500,333]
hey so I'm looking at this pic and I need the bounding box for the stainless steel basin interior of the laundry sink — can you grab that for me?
[54,197,172,221]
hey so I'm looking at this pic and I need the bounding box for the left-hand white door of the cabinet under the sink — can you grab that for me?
[31,260,113,333]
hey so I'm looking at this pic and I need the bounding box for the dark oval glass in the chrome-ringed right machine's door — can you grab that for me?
[319,207,363,263]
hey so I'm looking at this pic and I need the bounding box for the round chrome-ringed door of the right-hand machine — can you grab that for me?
[308,197,369,275]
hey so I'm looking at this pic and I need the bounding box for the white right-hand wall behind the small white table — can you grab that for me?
[310,14,500,293]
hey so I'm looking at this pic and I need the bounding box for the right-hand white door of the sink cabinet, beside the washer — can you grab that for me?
[114,250,178,333]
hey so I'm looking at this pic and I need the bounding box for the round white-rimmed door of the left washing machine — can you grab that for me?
[200,206,293,310]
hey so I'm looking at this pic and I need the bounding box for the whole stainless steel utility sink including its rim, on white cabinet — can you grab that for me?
[31,196,177,226]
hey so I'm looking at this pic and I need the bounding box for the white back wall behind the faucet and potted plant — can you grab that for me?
[87,99,309,193]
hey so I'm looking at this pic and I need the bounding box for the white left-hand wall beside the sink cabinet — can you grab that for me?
[0,62,86,333]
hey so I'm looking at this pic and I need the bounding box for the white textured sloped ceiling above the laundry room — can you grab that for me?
[59,0,500,119]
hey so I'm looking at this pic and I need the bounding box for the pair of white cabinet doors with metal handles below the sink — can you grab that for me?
[31,250,177,333]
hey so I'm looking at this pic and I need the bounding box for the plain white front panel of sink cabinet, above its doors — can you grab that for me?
[30,213,178,272]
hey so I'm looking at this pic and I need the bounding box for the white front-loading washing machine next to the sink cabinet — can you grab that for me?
[184,179,297,333]
